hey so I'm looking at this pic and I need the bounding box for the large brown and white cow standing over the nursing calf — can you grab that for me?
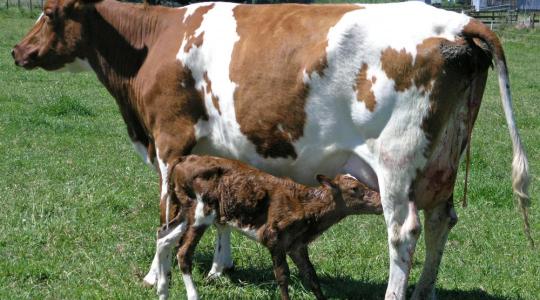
[13,0,529,299]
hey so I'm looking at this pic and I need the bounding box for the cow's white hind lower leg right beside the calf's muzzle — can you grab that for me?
[381,177,421,299]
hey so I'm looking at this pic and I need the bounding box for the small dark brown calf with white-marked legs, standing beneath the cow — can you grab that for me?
[158,155,382,299]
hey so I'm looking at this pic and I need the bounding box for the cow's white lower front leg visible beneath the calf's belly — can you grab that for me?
[207,224,233,280]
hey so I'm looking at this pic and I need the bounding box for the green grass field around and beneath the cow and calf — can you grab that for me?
[0,10,540,299]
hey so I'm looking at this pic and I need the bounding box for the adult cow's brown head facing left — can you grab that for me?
[11,0,95,70]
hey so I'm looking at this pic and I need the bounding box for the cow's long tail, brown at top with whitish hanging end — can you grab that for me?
[463,19,534,246]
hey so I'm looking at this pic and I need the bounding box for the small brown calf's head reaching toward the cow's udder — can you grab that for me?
[317,174,382,214]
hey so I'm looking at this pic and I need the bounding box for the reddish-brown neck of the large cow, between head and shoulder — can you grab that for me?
[85,0,171,145]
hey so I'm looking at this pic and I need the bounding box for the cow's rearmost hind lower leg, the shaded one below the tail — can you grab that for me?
[412,197,457,300]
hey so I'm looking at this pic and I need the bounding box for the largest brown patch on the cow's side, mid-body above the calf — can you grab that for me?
[229,5,361,159]
